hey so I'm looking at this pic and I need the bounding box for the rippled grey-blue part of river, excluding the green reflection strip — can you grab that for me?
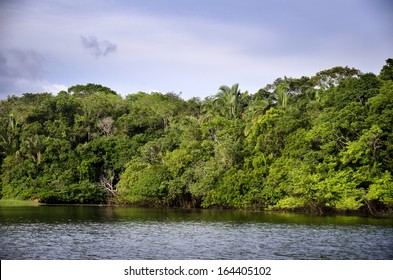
[0,207,393,259]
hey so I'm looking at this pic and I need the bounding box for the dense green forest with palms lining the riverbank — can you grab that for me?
[0,59,393,215]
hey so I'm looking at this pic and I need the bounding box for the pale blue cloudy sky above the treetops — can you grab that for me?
[0,0,393,99]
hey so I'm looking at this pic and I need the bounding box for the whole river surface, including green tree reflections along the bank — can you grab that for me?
[0,206,393,260]
